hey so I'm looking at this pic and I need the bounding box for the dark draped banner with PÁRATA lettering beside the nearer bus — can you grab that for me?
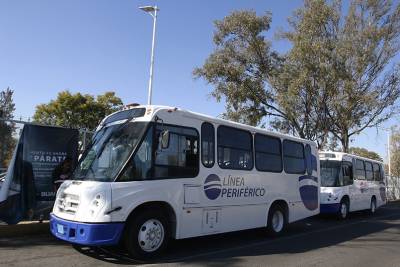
[0,124,79,223]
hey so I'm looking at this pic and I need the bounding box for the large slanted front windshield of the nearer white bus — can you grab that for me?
[73,122,148,182]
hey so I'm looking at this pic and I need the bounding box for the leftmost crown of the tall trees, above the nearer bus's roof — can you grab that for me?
[193,11,281,125]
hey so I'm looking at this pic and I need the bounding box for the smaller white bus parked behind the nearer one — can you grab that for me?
[319,151,386,219]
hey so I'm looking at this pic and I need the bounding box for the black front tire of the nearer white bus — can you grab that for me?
[124,210,171,260]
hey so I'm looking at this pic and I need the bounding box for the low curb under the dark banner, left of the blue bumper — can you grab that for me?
[0,221,50,238]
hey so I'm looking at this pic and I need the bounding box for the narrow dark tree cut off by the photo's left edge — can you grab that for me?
[0,88,15,168]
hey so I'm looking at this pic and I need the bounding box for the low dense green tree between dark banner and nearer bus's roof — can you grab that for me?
[33,91,123,130]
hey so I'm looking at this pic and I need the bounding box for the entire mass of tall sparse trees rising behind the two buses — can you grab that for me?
[194,0,400,152]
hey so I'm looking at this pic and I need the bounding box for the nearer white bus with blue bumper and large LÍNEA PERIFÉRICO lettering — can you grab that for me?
[50,106,320,259]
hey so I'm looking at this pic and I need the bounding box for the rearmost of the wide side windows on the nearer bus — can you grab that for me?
[283,140,306,174]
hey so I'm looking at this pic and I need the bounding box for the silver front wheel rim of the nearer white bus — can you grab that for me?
[138,219,165,252]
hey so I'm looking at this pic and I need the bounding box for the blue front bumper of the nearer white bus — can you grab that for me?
[50,213,124,246]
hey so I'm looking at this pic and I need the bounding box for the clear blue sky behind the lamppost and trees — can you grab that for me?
[0,0,399,161]
